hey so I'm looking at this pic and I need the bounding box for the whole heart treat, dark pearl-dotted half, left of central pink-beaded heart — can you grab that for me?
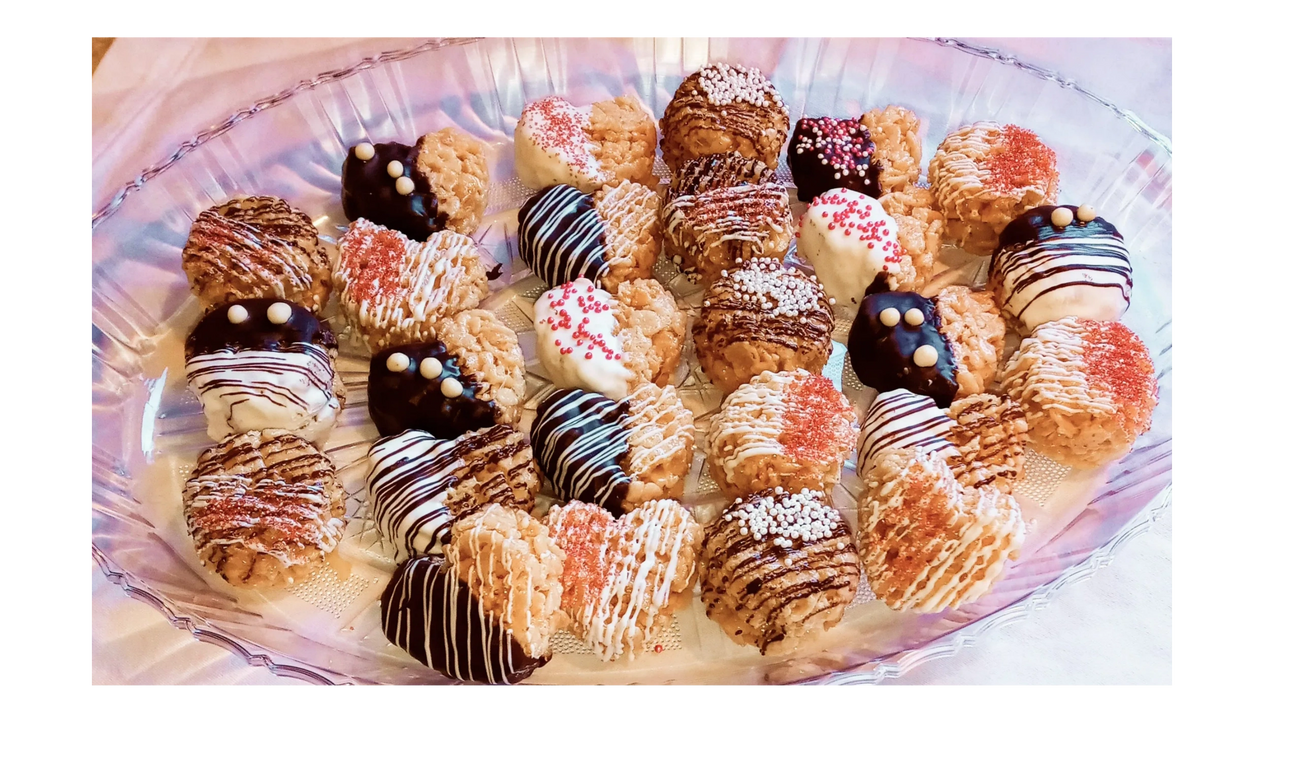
[365,309,525,439]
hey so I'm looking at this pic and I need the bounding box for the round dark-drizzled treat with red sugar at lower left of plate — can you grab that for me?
[183,432,346,589]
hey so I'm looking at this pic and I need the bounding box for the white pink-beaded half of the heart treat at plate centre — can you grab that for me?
[533,278,633,400]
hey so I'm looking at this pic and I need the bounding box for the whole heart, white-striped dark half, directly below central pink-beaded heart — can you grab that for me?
[530,384,696,515]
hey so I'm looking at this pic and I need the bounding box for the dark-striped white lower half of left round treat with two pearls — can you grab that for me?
[185,342,339,441]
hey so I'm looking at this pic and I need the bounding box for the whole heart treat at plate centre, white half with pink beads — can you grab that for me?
[533,280,686,400]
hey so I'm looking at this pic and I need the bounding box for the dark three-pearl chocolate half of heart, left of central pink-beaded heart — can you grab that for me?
[365,339,497,439]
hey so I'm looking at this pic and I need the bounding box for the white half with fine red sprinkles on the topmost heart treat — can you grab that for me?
[515,95,612,192]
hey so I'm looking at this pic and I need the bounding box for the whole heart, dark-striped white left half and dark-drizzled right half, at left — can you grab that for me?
[365,424,541,560]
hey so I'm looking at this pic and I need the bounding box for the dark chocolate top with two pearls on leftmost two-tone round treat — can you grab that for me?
[185,298,338,360]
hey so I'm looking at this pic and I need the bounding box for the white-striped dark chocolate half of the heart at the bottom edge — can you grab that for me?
[380,556,550,684]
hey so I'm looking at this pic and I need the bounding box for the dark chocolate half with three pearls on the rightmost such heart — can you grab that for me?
[849,290,957,408]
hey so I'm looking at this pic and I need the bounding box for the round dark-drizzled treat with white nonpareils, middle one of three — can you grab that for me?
[692,257,835,393]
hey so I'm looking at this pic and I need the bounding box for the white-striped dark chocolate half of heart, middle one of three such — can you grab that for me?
[530,389,632,516]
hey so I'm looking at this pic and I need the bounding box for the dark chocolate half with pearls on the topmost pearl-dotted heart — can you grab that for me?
[343,142,447,242]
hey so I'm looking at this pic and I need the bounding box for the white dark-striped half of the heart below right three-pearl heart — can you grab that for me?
[858,389,957,476]
